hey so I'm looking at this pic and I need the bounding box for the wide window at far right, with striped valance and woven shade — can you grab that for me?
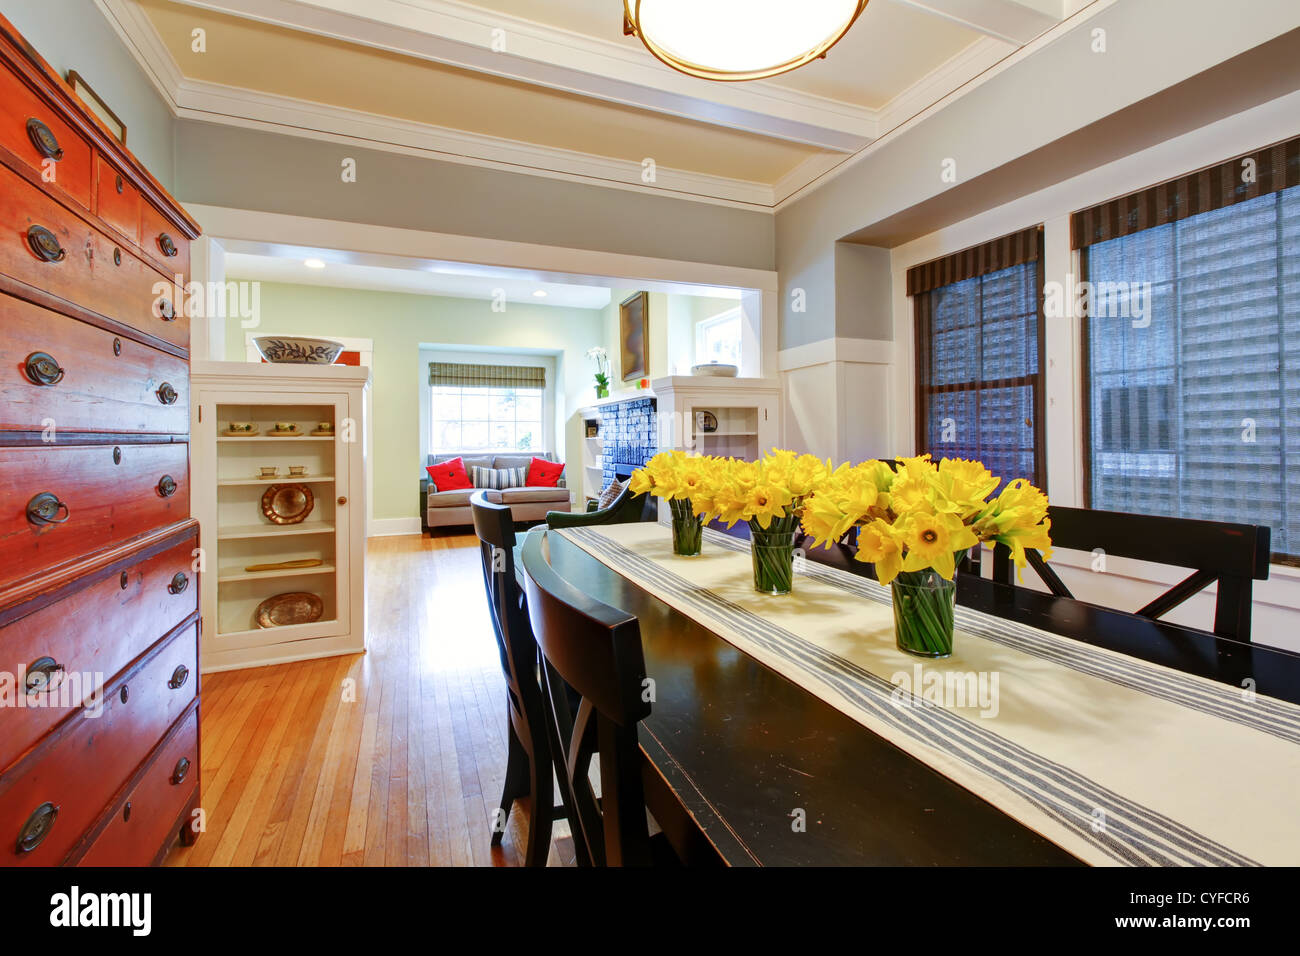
[1073,140,1300,563]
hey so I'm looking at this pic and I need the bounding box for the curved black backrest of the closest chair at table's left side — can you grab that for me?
[523,531,653,866]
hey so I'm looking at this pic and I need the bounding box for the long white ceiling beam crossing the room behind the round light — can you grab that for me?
[162,0,878,152]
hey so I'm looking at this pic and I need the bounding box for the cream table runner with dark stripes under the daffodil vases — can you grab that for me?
[553,523,1300,866]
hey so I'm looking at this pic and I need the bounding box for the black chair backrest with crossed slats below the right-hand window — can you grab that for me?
[993,505,1271,641]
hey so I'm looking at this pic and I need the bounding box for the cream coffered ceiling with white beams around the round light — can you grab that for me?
[96,0,1088,208]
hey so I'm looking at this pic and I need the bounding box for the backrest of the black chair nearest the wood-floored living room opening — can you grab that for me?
[469,492,547,754]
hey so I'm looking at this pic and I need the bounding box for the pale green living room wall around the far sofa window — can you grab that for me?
[226,282,602,520]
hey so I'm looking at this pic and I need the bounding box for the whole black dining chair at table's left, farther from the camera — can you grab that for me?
[469,492,585,866]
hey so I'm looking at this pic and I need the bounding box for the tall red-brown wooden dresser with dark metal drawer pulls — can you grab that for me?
[0,17,203,866]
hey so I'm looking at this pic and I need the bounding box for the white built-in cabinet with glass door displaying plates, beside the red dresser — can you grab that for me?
[191,362,369,671]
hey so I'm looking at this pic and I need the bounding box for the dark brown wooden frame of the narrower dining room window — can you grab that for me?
[910,225,1048,494]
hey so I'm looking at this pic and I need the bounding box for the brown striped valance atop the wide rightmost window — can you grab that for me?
[1070,138,1300,248]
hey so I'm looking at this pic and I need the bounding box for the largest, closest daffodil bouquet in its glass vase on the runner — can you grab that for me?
[802,455,1052,657]
